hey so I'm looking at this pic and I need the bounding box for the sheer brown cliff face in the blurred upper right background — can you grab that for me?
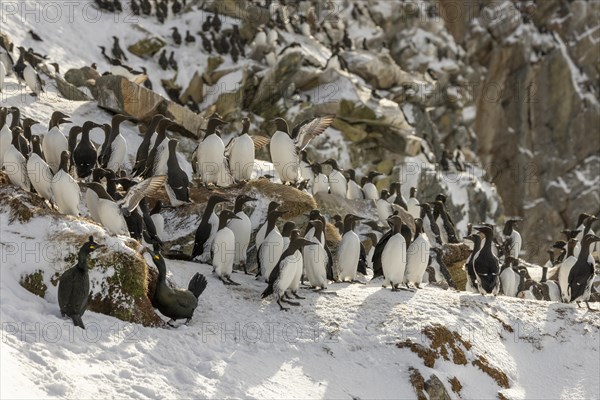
[439,0,600,261]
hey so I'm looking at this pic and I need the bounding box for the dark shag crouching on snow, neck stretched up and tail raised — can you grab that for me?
[149,245,207,326]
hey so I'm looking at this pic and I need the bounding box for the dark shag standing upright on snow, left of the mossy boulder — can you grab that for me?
[58,236,104,329]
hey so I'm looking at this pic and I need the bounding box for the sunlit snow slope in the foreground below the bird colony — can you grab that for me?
[0,242,600,399]
